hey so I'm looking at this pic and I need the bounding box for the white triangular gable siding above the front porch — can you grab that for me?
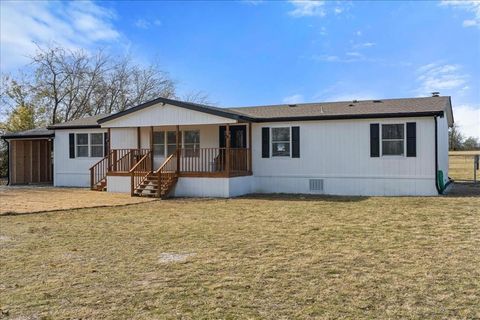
[102,104,236,128]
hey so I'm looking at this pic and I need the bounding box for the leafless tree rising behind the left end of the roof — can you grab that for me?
[2,46,175,124]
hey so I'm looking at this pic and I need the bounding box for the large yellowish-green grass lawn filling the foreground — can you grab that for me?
[0,196,480,319]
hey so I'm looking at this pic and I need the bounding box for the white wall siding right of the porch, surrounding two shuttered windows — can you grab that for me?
[252,117,437,195]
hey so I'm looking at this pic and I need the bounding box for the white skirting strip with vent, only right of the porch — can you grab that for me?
[252,177,437,196]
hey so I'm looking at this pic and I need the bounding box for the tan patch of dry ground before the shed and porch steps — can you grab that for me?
[0,186,151,215]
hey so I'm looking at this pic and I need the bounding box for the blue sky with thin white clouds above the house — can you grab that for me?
[0,0,480,137]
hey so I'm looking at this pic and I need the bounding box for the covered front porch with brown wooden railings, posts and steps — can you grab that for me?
[90,122,252,197]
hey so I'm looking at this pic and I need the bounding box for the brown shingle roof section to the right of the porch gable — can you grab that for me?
[228,97,450,121]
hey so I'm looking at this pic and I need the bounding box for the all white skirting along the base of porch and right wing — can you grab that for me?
[107,176,437,198]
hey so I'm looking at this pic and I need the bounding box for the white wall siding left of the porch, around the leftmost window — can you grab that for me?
[53,128,107,187]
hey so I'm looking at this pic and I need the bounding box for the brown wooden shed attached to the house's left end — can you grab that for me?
[2,128,54,185]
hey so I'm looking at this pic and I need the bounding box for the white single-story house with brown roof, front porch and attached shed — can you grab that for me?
[3,96,453,197]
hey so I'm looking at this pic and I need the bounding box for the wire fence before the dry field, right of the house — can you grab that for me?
[448,151,480,183]
